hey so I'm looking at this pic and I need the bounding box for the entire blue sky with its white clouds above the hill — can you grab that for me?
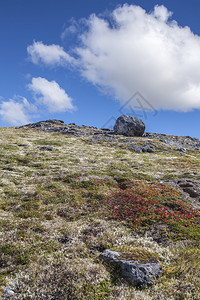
[0,0,200,138]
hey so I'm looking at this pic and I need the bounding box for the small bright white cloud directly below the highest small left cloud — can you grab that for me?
[28,77,75,113]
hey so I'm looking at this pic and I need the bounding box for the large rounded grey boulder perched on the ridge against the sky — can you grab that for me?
[113,115,145,136]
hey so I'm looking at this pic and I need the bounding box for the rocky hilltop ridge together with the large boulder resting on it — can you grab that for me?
[16,116,200,155]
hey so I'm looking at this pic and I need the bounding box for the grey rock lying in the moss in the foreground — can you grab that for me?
[101,250,162,286]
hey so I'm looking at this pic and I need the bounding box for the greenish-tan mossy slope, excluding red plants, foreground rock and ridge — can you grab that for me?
[0,128,200,300]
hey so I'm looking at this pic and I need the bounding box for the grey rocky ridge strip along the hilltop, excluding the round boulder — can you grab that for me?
[16,120,200,155]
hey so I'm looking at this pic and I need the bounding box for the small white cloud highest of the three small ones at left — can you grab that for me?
[27,42,74,66]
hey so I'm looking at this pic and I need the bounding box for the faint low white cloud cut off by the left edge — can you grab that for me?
[0,96,32,126]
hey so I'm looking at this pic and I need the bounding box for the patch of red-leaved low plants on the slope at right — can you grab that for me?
[104,181,200,238]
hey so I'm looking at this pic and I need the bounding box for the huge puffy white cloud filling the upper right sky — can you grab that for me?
[72,4,200,111]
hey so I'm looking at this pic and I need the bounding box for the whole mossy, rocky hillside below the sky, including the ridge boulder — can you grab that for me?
[0,116,200,300]
